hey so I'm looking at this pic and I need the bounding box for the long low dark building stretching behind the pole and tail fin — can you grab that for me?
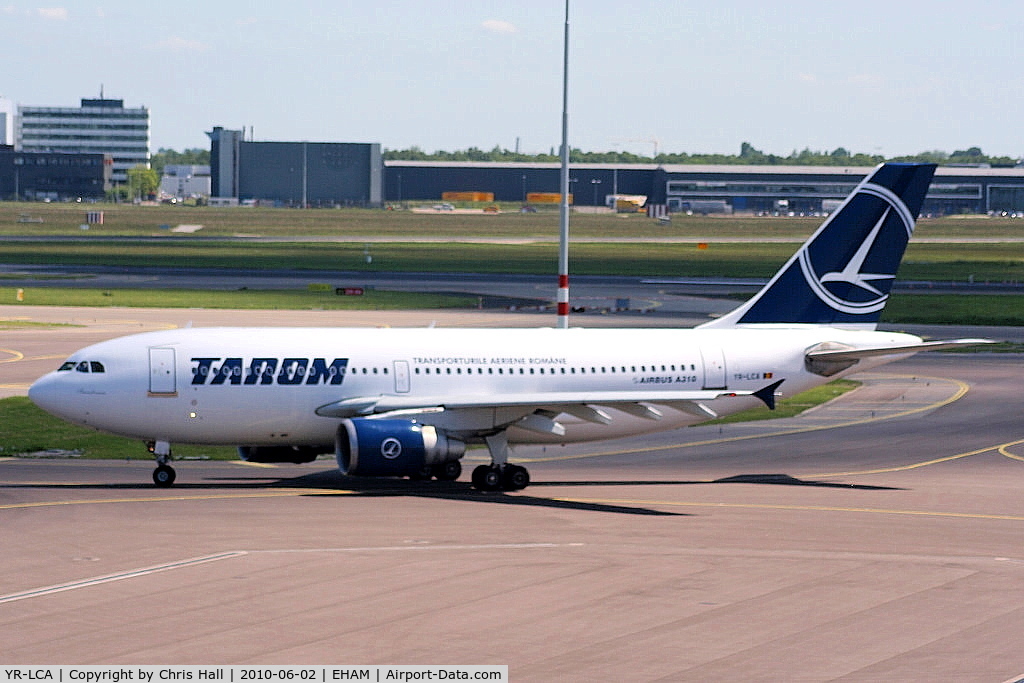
[384,161,1024,215]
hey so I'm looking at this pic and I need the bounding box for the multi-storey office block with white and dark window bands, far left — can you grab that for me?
[14,96,150,183]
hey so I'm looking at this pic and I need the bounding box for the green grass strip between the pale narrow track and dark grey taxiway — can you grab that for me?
[3,241,1024,283]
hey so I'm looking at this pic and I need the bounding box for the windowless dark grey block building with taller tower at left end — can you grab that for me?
[207,126,384,207]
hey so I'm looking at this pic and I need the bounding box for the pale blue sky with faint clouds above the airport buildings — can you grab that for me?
[0,0,1024,157]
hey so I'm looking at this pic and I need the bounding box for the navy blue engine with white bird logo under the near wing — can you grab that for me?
[334,418,466,476]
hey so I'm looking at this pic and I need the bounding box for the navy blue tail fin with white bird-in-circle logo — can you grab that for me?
[700,164,935,329]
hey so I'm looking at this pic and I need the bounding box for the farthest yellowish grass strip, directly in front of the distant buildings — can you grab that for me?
[6,202,1024,238]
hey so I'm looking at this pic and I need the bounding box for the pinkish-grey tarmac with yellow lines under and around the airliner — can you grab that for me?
[0,311,1024,681]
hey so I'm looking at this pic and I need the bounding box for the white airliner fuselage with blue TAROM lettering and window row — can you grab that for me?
[31,325,920,449]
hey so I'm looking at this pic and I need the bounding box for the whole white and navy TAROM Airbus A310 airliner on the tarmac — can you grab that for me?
[29,164,983,490]
